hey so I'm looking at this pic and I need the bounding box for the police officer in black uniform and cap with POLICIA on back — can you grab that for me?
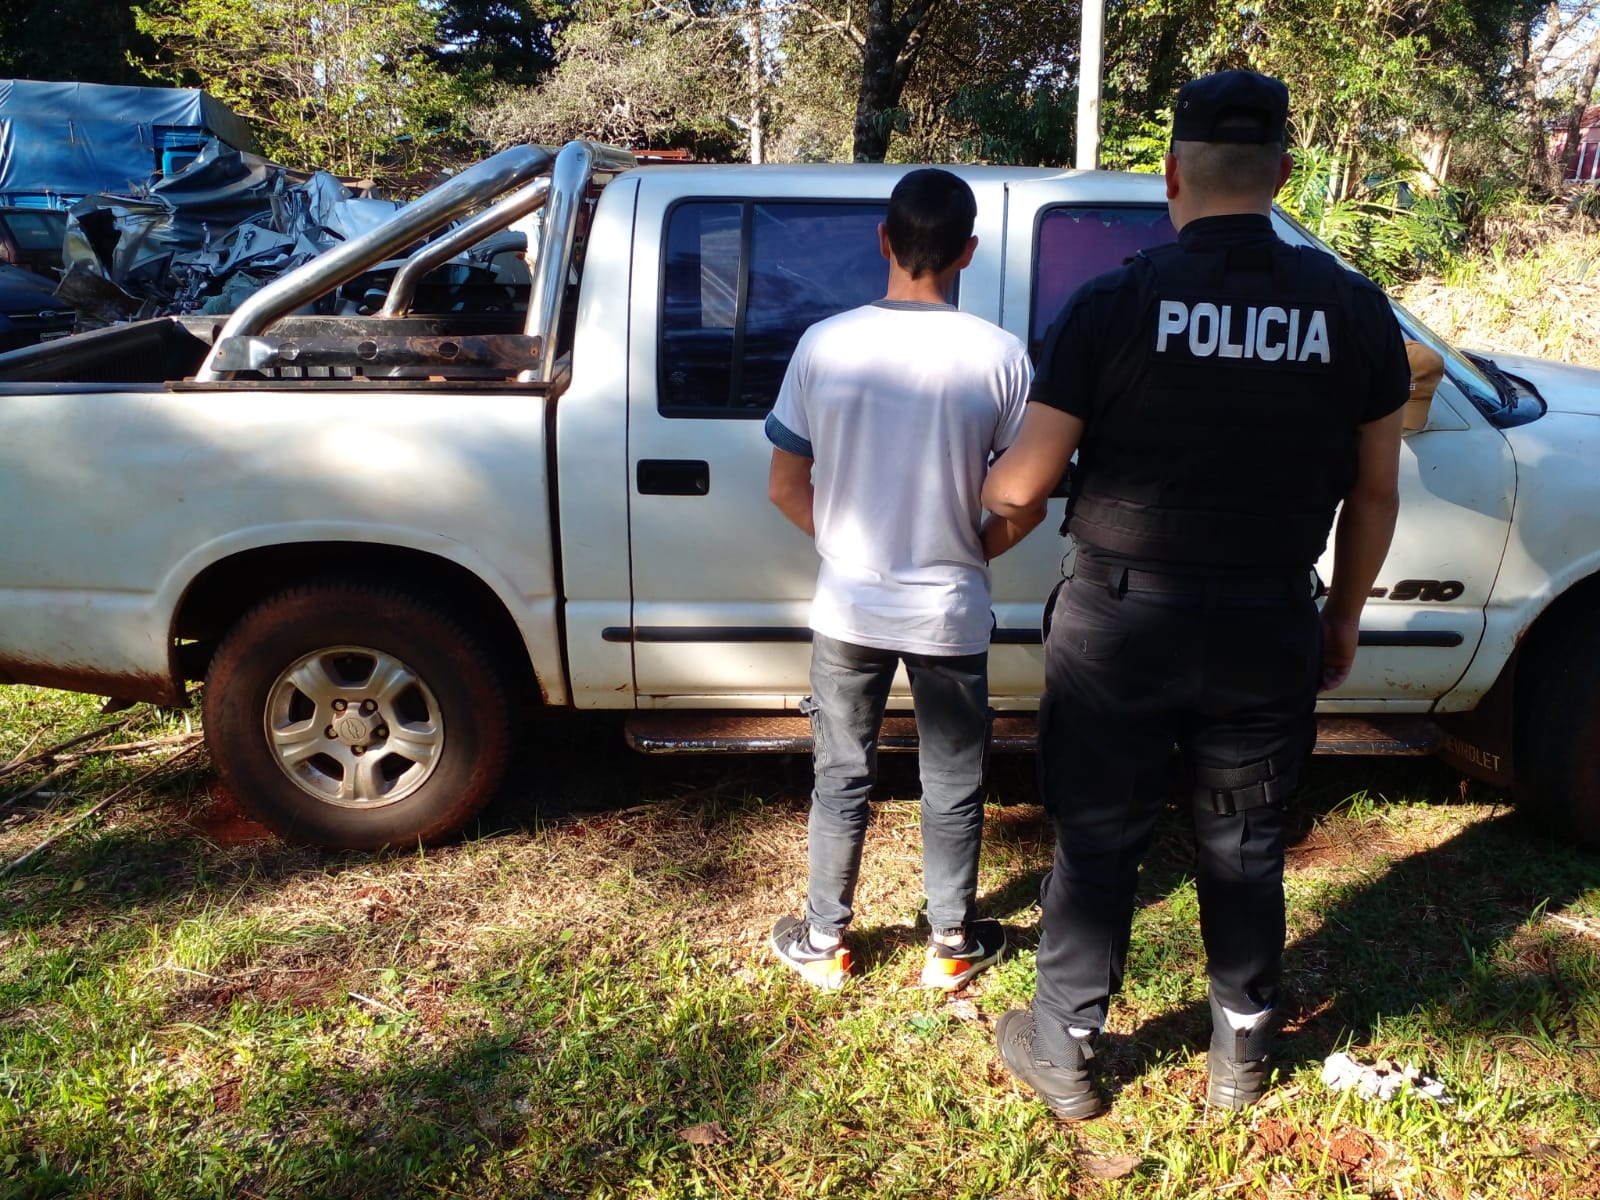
[982,70,1410,1118]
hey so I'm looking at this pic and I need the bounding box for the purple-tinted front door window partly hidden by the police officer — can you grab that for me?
[1027,205,1178,362]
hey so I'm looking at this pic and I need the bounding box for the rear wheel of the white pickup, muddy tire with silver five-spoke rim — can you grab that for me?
[205,582,510,850]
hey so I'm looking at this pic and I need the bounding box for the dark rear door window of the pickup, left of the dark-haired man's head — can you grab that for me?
[656,200,888,418]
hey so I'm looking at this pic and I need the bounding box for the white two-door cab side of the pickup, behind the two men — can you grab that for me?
[598,166,1515,714]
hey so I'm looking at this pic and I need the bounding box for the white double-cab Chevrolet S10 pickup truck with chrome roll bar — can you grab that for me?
[0,142,1600,848]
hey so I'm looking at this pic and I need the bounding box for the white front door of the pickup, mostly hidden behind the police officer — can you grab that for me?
[995,182,1515,712]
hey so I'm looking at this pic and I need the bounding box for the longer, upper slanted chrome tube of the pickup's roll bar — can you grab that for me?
[195,146,556,382]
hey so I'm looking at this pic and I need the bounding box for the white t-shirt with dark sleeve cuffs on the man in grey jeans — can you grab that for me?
[766,301,1034,654]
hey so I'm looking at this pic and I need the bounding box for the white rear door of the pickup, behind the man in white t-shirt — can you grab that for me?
[613,166,1037,709]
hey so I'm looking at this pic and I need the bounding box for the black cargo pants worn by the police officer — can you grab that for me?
[1034,554,1322,1030]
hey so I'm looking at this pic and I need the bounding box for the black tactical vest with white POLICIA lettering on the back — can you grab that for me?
[1066,235,1370,568]
